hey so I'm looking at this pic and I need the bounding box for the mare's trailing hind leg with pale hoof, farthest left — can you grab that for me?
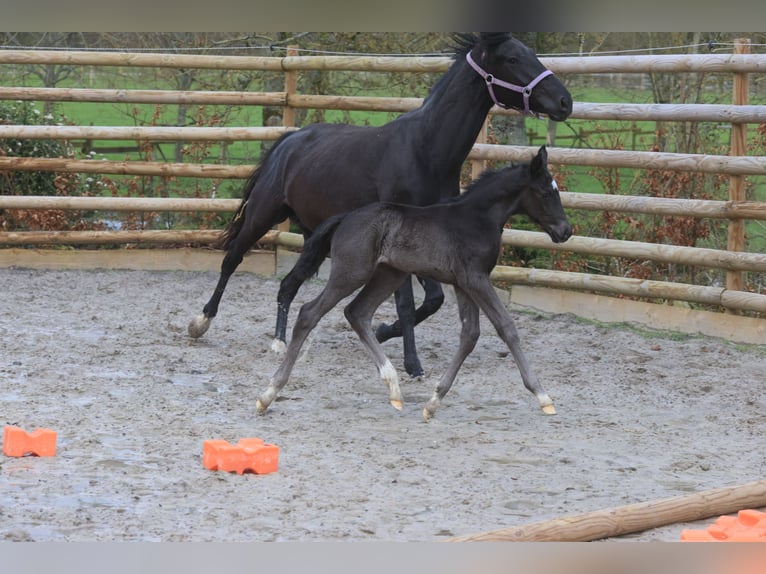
[188,201,289,339]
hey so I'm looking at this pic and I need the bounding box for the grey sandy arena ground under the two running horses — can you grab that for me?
[0,269,766,541]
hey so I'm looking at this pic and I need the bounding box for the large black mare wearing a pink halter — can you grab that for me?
[189,33,572,376]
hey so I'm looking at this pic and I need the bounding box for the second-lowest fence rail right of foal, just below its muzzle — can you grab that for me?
[503,229,766,272]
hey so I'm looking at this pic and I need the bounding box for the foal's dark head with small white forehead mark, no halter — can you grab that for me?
[519,146,572,243]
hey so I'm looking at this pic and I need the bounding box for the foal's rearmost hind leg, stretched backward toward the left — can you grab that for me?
[256,273,364,414]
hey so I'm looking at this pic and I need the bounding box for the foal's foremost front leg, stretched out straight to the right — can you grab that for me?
[466,276,556,415]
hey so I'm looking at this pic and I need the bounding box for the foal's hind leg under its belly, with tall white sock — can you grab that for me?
[344,265,407,410]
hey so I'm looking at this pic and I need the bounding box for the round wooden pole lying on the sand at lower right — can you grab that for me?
[449,480,766,542]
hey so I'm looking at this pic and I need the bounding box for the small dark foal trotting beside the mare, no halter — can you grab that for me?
[256,147,572,420]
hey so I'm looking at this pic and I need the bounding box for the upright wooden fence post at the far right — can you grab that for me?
[726,38,750,291]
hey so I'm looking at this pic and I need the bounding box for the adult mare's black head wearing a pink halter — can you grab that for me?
[457,33,572,121]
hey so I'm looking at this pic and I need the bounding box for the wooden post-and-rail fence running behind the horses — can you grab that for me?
[0,42,766,324]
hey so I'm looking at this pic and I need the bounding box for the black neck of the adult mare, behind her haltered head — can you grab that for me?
[404,59,492,178]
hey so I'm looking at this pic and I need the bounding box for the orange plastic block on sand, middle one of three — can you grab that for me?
[202,438,279,474]
